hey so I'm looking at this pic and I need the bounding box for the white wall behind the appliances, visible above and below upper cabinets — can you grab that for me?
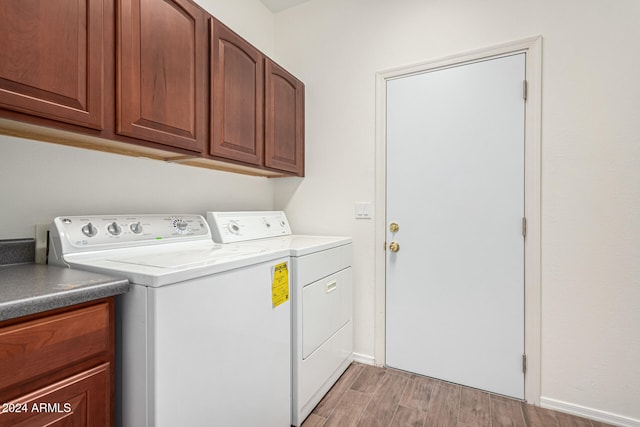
[0,0,274,239]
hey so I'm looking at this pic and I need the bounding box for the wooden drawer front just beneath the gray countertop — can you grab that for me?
[0,303,109,387]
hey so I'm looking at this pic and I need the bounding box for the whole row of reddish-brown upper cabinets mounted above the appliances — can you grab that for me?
[0,0,304,177]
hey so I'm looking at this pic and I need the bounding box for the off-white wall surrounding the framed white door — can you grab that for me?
[275,0,640,425]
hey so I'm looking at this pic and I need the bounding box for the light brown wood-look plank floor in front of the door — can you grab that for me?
[302,363,607,427]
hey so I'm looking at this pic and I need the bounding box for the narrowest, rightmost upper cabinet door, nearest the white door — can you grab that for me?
[265,59,304,176]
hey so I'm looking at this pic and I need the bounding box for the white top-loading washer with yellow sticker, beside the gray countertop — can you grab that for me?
[50,215,291,427]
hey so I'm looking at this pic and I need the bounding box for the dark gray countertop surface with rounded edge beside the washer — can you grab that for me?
[0,264,129,321]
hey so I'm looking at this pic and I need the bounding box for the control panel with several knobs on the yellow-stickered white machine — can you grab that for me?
[53,215,211,248]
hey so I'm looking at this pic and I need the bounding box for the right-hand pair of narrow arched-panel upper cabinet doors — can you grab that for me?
[210,19,304,176]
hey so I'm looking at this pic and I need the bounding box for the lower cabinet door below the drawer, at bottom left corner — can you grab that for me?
[0,363,112,427]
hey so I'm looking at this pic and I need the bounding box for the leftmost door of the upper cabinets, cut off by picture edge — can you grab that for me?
[0,0,105,129]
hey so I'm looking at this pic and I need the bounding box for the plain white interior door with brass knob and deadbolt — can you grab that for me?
[386,53,525,398]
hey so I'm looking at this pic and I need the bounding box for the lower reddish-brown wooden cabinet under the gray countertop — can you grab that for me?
[0,298,114,427]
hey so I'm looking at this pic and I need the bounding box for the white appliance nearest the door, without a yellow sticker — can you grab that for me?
[207,211,353,426]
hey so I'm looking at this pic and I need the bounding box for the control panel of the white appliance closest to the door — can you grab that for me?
[207,211,291,243]
